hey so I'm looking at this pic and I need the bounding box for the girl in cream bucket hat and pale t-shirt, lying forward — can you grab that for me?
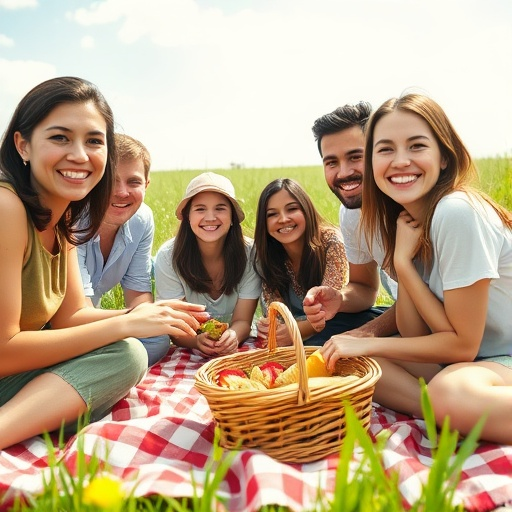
[155,172,261,357]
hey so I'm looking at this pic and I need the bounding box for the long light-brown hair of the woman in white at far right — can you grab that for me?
[361,94,512,271]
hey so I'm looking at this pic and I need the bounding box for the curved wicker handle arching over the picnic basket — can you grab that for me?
[268,302,309,405]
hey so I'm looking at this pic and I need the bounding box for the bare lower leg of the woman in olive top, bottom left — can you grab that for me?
[0,373,87,450]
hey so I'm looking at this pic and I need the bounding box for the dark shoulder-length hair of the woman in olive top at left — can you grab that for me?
[0,77,116,245]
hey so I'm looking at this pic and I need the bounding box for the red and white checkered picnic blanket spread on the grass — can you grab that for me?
[0,348,512,512]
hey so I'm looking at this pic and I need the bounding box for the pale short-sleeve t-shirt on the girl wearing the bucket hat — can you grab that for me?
[155,237,261,316]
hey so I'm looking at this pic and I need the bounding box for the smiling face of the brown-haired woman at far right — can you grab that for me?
[372,110,446,219]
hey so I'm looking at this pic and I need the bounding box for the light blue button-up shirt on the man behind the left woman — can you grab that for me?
[78,203,155,306]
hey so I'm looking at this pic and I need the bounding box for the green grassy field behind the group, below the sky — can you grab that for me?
[145,157,512,254]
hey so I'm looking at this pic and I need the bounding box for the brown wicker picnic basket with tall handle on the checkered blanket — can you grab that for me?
[195,302,381,463]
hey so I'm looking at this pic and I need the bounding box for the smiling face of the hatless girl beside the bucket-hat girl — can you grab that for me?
[266,189,306,246]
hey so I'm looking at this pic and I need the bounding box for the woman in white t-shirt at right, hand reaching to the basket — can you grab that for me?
[310,94,512,444]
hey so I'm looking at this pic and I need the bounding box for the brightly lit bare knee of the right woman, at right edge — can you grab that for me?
[428,362,512,444]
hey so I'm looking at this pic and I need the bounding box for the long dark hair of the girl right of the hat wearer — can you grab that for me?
[254,178,327,299]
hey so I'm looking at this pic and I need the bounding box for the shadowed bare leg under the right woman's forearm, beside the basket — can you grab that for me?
[373,358,441,417]
